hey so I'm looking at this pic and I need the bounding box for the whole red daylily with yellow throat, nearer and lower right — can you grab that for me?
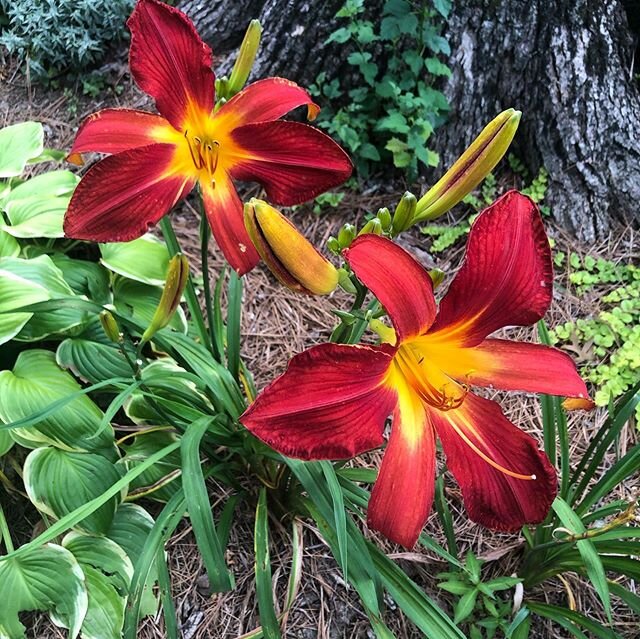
[241,191,587,548]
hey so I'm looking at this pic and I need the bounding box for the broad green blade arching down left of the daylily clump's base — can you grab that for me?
[180,417,232,592]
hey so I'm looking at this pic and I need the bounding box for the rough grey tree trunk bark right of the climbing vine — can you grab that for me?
[437,0,640,241]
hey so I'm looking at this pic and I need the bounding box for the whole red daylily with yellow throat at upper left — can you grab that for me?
[64,0,352,274]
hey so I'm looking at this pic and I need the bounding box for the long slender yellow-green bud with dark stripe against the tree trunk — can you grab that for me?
[415,109,522,221]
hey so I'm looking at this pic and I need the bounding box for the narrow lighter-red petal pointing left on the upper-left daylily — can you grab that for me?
[69,109,169,161]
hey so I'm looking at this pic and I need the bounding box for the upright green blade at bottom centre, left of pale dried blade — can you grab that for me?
[254,488,281,639]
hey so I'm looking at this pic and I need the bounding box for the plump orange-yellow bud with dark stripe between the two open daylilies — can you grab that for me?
[244,198,338,295]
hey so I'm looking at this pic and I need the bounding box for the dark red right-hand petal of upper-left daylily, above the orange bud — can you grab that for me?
[229,121,352,206]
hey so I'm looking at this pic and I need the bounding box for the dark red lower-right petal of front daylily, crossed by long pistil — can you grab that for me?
[429,393,557,531]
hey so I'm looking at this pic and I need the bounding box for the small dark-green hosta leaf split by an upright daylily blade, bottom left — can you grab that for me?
[107,503,158,617]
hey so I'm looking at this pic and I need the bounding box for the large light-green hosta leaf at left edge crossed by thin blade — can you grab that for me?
[0,350,113,451]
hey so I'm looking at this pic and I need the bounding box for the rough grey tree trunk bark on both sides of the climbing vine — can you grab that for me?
[180,0,640,241]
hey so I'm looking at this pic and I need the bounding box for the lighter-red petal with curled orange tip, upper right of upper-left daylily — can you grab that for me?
[215,78,320,130]
